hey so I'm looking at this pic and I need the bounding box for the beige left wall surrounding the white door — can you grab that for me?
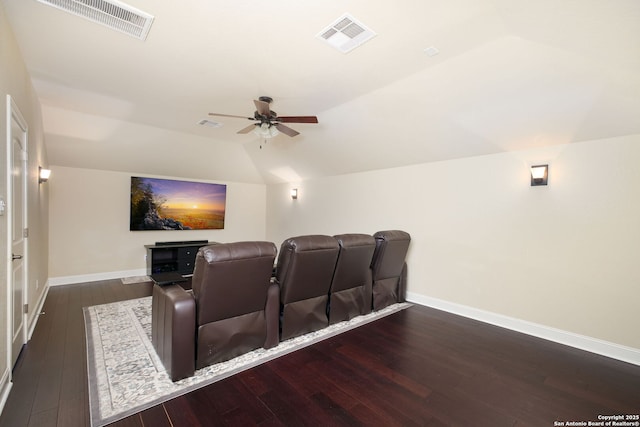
[0,3,48,408]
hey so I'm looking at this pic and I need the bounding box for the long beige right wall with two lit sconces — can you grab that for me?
[267,135,640,361]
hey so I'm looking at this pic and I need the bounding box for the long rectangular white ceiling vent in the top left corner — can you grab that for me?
[38,0,153,40]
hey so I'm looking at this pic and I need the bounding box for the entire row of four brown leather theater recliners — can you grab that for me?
[152,231,410,381]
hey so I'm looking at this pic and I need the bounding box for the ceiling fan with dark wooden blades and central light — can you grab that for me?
[209,96,318,138]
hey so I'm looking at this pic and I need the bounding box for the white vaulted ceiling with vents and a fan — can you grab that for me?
[0,0,640,183]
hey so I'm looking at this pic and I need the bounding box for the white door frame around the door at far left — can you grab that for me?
[6,95,29,372]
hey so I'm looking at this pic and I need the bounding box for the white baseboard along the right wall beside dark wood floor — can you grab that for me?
[407,292,640,366]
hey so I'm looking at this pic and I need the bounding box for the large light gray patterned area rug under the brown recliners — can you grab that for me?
[84,297,411,427]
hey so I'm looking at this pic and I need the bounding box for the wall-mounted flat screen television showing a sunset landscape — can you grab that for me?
[129,176,227,231]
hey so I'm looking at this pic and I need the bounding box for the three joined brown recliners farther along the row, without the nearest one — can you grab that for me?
[276,230,411,341]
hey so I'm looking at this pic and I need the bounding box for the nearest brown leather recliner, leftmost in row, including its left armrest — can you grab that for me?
[152,242,279,381]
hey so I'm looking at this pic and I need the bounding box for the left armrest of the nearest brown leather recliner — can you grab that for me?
[151,285,196,381]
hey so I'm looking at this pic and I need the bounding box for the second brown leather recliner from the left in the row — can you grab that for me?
[276,235,339,341]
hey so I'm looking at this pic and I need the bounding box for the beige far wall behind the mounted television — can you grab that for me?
[48,166,266,284]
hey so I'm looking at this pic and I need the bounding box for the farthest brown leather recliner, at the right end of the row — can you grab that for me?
[371,230,411,310]
